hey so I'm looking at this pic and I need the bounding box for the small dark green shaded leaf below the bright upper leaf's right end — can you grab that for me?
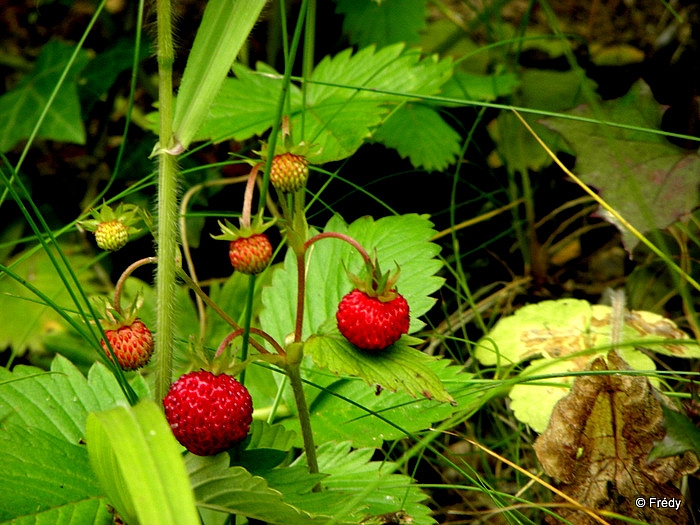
[373,104,462,171]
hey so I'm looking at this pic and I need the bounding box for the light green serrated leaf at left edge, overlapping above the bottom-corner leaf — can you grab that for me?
[0,355,126,443]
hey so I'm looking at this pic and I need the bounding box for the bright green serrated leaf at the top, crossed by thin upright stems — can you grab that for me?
[197,44,452,164]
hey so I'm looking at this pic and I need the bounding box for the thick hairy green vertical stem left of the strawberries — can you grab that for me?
[155,0,178,400]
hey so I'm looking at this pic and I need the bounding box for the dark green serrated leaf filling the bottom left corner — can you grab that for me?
[0,424,107,523]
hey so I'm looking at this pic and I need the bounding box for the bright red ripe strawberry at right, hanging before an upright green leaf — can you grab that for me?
[335,289,410,351]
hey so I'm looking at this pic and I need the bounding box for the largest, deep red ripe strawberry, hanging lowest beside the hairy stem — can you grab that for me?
[163,370,253,456]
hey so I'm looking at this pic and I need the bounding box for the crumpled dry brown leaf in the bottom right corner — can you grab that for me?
[535,351,700,525]
